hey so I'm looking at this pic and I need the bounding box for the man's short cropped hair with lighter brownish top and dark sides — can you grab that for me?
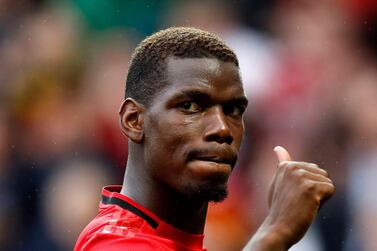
[125,27,239,107]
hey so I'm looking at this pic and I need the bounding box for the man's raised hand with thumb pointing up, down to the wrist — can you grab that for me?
[265,146,335,248]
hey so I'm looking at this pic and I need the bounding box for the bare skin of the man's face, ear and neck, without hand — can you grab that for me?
[120,58,247,234]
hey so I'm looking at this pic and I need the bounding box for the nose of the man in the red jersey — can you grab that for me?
[204,107,233,145]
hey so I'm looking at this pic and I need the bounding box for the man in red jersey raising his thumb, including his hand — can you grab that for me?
[75,28,334,251]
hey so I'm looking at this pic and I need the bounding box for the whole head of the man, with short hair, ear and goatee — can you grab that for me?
[121,28,247,201]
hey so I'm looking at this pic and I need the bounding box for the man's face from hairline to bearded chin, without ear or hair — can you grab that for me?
[143,58,247,201]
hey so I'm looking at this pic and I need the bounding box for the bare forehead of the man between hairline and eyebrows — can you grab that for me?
[162,57,244,96]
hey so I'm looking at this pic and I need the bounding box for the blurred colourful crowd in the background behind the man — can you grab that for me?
[0,0,377,251]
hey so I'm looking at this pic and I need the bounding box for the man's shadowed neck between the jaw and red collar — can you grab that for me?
[121,146,208,234]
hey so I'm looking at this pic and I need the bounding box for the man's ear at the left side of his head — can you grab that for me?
[119,98,145,143]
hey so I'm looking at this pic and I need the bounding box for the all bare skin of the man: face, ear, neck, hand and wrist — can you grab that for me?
[120,57,334,250]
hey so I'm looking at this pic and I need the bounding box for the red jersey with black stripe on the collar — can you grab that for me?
[74,186,206,251]
